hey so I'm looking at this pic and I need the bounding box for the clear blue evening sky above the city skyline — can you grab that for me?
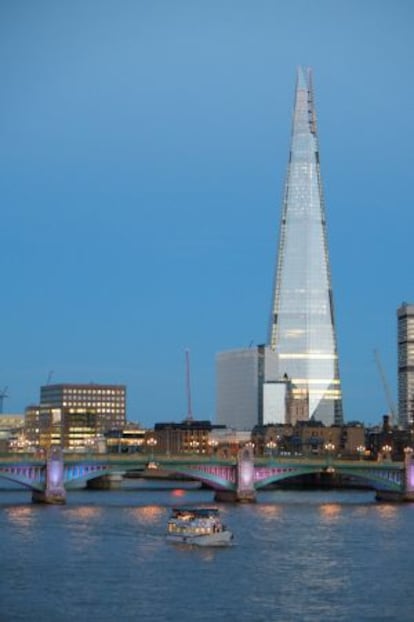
[0,0,414,426]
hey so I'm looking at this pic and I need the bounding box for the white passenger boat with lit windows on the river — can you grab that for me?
[166,507,233,546]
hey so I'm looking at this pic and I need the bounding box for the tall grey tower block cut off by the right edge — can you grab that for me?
[397,302,414,428]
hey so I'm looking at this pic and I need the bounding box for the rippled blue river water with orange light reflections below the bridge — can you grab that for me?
[0,480,414,622]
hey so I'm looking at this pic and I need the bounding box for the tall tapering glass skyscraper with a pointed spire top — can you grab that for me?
[269,67,343,425]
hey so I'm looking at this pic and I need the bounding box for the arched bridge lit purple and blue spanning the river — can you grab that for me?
[0,447,414,503]
